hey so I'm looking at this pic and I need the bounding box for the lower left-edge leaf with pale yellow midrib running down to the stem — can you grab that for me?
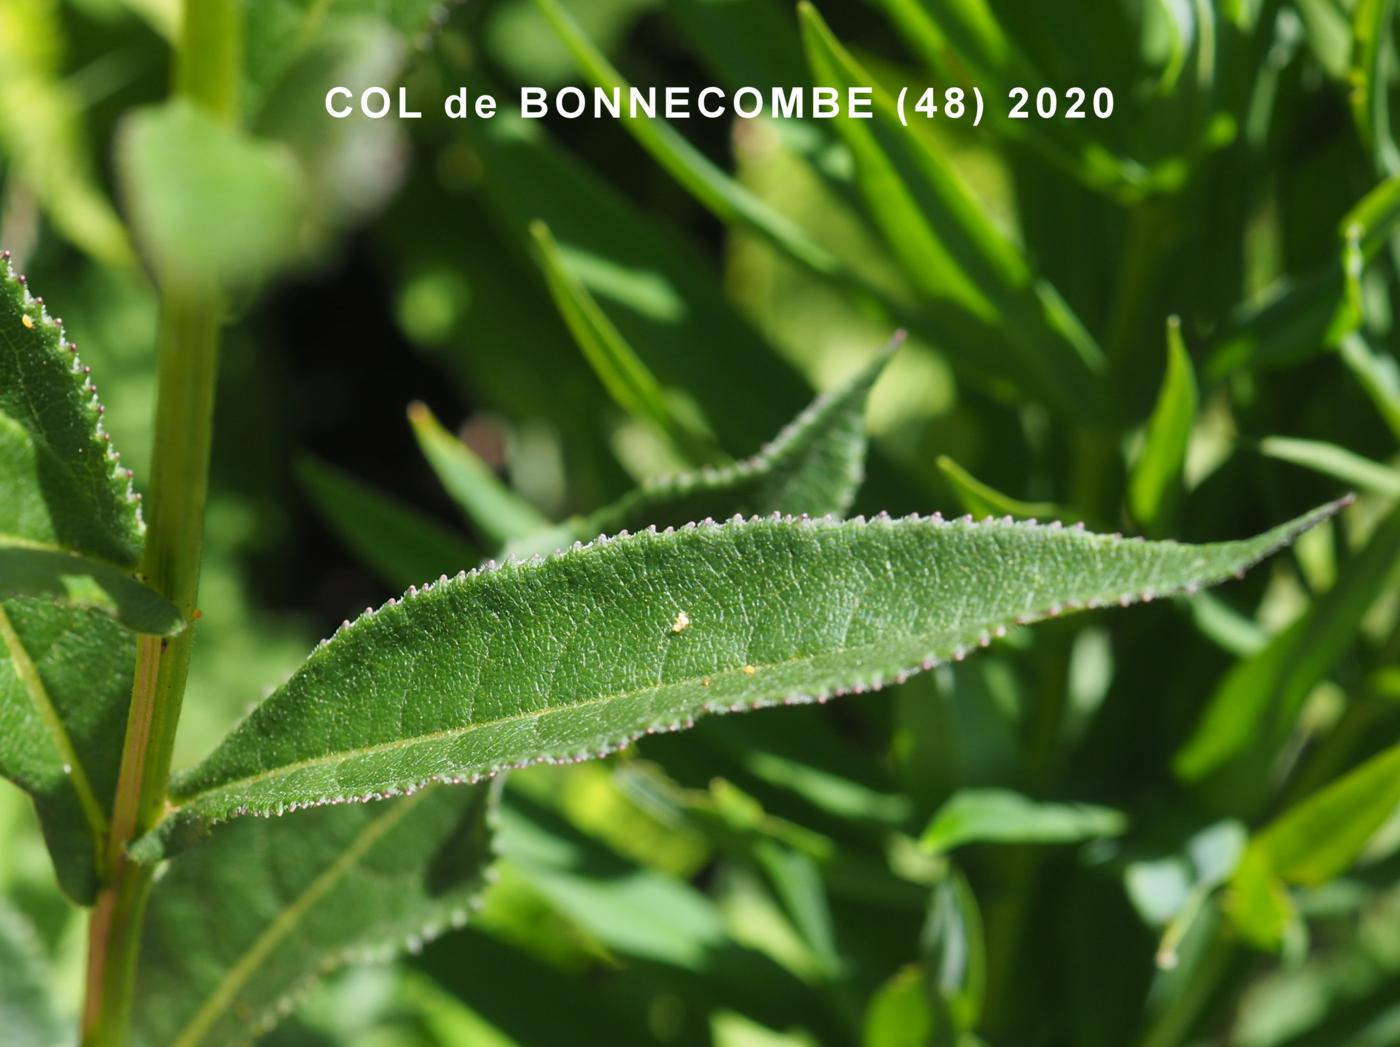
[0,599,136,904]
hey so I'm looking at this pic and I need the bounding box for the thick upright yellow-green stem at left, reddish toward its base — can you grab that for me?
[83,0,242,1047]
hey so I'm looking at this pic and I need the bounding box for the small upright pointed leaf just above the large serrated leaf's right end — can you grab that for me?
[1128,316,1197,530]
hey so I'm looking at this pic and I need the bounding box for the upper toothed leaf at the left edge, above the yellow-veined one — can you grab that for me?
[0,252,183,634]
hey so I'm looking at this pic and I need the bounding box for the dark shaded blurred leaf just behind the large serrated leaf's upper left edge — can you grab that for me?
[298,456,482,589]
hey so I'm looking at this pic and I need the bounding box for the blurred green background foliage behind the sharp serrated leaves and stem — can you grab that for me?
[0,0,1400,1047]
